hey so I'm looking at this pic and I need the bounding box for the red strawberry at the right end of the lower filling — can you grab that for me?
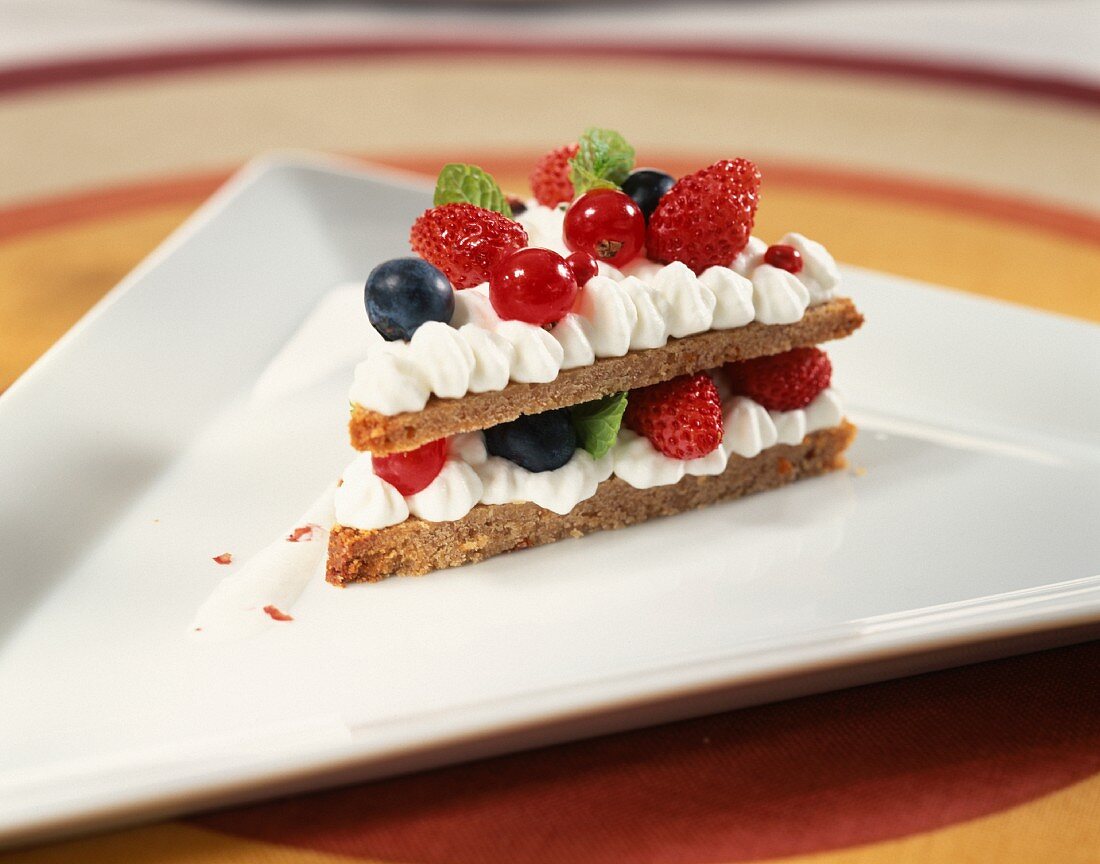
[726,348,833,411]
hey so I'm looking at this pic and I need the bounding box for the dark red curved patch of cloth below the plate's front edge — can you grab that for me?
[193,643,1100,864]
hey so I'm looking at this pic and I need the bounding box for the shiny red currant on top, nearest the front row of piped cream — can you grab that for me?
[488,248,579,327]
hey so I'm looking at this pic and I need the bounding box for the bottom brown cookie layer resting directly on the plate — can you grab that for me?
[326,423,856,586]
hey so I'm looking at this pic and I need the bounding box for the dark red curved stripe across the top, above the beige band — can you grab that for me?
[0,40,1100,109]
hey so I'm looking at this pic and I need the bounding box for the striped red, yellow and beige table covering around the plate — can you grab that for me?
[0,0,1100,864]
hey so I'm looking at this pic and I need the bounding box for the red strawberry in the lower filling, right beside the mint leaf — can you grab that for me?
[623,372,724,459]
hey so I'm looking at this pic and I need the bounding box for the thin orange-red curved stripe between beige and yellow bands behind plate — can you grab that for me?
[0,153,1100,243]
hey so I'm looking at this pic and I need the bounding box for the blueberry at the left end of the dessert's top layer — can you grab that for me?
[363,258,454,342]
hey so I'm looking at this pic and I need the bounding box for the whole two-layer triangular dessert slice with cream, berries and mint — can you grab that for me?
[328,130,862,584]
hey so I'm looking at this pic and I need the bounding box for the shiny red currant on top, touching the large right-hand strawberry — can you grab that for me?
[563,189,646,267]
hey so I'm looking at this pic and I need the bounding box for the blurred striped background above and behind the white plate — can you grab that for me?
[0,0,1100,389]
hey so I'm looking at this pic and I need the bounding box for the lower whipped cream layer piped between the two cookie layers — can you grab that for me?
[336,389,844,531]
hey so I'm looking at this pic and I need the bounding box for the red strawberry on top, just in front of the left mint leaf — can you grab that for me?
[409,204,527,288]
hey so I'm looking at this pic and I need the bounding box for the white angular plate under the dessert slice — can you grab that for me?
[0,152,1100,842]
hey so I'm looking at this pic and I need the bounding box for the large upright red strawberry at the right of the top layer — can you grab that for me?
[646,158,760,273]
